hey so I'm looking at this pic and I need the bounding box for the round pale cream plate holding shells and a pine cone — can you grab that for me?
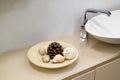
[27,41,79,69]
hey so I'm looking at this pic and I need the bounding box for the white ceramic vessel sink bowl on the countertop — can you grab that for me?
[85,10,120,44]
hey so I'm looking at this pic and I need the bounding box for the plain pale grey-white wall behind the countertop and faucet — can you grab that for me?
[0,0,120,53]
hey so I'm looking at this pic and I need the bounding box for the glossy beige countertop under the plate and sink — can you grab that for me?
[0,33,120,80]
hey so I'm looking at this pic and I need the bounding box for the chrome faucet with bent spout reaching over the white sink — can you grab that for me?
[80,9,111,41]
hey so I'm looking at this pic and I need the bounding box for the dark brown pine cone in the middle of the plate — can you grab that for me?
[47,42,63,59]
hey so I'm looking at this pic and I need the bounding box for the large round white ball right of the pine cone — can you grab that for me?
[63,47,75,59]
